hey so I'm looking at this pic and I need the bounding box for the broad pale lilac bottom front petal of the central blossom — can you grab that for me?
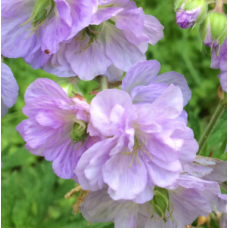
[102,154,147,200]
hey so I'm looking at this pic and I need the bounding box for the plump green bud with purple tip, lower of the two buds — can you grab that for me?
[199,11,227,48]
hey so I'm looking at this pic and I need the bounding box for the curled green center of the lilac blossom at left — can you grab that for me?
[70,120,89,146]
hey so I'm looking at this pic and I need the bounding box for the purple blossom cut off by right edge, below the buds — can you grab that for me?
[211,39,227,92]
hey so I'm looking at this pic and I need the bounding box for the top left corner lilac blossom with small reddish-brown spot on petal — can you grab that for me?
[1,0,96,58]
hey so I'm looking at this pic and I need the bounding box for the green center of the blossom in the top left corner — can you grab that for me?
[21,0,55,35]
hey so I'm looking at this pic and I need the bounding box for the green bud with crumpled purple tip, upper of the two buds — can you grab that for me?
[174,0,207,28]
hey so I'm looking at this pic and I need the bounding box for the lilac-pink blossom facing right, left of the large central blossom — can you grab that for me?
[16,78,100,178]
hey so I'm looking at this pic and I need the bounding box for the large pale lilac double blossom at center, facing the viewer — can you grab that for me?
[75,61,198,203]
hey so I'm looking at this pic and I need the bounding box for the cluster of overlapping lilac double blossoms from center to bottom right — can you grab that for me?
[17,60,226,228]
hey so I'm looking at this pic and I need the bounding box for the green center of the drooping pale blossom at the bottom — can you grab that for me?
[150,186,176,223]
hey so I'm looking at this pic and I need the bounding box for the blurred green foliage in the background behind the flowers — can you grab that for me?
[1,0,227,228]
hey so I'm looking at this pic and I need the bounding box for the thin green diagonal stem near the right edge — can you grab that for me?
[197,101,225,155]
